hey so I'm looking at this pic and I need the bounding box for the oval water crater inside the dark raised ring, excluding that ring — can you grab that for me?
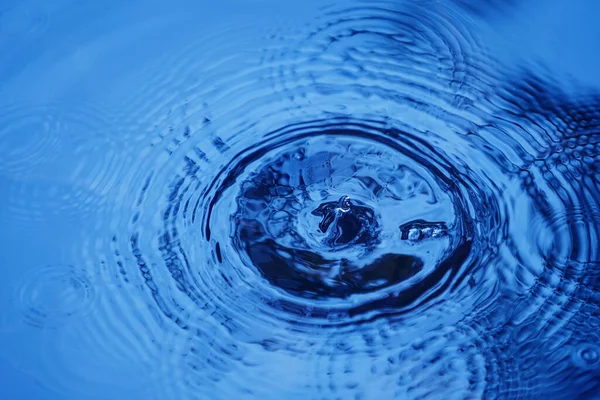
[218,133,466,299]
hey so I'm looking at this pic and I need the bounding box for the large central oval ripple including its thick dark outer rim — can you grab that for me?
[204,120,486,317]
